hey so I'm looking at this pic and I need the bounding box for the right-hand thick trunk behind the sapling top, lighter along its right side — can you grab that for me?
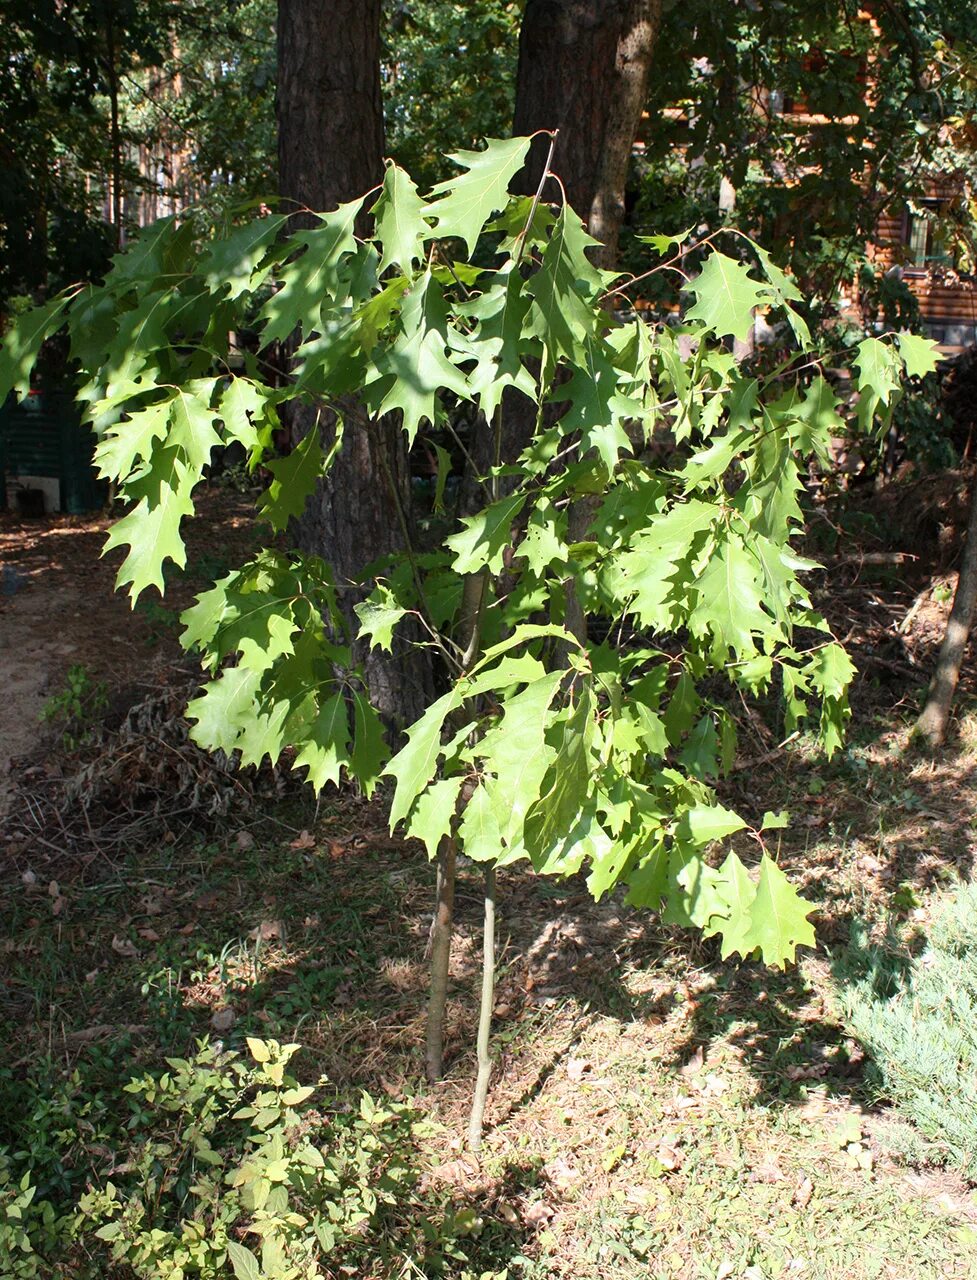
[512,0,662,266]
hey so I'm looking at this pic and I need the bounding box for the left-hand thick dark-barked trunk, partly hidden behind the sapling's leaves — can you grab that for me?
[278,0,428,727]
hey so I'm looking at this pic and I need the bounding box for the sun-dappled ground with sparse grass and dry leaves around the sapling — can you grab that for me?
[0,477,977,1280]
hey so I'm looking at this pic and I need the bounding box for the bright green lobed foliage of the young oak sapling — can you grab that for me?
[0,138,932,964]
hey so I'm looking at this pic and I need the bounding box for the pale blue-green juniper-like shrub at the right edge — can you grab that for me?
[835,882,977,1181]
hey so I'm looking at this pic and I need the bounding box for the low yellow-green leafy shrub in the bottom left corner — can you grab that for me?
[0,1039,481,1280]
